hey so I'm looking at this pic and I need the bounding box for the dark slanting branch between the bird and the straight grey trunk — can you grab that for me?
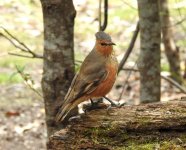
[118,21,139,73]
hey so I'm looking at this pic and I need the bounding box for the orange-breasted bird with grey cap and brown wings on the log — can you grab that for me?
[56,31,118,122]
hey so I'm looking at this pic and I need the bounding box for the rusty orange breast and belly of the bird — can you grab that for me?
[90,65,117,97]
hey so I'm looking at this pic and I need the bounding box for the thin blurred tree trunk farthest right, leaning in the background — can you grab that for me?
[159,0,182,83]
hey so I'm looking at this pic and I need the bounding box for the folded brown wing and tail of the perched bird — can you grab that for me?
[56,65,108,122]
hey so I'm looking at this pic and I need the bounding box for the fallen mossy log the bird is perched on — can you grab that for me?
[48,101,186,150]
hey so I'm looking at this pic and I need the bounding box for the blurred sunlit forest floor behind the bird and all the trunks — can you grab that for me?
[0,0,186,150]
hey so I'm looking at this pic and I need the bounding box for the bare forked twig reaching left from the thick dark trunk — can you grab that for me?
[0,27,43,59]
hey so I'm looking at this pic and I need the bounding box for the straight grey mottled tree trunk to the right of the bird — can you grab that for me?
[138,0,161,103]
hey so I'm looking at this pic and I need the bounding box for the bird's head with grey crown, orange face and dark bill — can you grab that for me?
[95,31,115,56]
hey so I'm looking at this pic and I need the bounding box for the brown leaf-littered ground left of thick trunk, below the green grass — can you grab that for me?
[0,84,46,150]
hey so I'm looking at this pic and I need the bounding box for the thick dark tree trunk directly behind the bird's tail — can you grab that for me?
[41,0,76,136]
